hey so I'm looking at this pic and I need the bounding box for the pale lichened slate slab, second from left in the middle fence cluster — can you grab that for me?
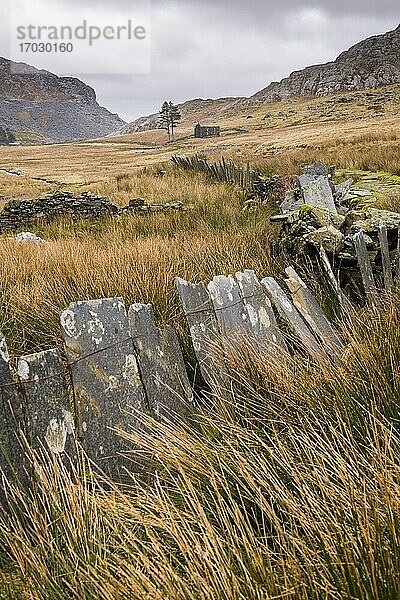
[208,275,252,337]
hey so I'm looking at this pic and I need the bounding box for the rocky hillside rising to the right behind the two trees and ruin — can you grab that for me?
[120,25,400,133]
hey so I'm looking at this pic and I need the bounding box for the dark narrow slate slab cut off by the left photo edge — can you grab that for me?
[0,332,26,488]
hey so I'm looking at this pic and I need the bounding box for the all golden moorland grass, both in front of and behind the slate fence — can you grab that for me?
[0,111,400,600]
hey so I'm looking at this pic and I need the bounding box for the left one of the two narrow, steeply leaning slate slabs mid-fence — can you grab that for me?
[261,277,327,362]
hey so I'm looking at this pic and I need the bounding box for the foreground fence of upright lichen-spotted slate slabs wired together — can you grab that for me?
[0,227,400,488]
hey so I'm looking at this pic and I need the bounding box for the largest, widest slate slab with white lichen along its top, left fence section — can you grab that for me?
[61,298,147,478]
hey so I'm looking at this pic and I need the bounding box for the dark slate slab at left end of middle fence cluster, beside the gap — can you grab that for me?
[176,278,224,389]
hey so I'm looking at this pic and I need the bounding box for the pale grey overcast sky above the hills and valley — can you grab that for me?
[0,0,400,121]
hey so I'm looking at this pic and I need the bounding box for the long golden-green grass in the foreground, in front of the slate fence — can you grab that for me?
[0,295,400,600]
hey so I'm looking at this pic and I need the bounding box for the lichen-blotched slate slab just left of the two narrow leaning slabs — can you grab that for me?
[236,269,287,354]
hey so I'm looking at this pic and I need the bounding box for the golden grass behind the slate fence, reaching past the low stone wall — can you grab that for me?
[0,168,282,354]
